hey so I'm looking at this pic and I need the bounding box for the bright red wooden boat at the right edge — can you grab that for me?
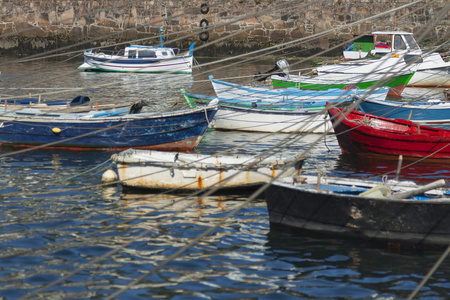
[328,108,450,159]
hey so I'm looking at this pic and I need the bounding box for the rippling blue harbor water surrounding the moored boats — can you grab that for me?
[0,56,450,300]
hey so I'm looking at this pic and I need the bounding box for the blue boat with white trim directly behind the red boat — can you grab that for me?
[359,100,450,124]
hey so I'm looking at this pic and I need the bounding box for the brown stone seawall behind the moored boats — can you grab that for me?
[0,0,450,56]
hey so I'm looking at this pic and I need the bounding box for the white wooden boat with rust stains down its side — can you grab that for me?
[112,149,305,190]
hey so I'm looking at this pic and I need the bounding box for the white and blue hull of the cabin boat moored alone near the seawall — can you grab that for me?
[78,53,193,74]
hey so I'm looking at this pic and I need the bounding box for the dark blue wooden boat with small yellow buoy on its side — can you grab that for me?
[0,103,218,151]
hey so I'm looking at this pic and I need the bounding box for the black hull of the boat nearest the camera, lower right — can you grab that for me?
[265,179,450,247]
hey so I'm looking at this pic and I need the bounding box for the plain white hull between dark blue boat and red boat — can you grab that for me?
[213,106,333,133]
